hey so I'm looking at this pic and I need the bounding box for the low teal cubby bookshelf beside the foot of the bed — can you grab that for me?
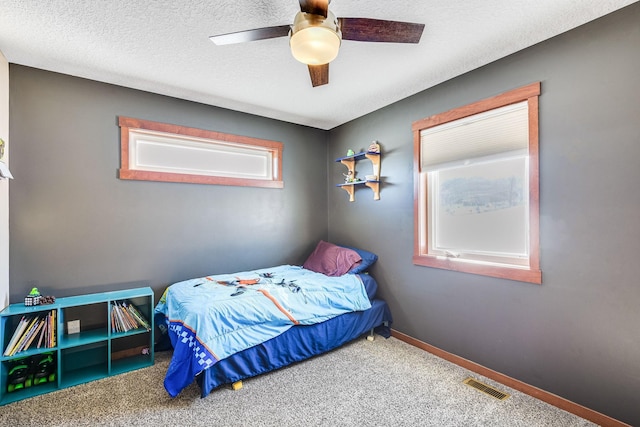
[0,287,154,405]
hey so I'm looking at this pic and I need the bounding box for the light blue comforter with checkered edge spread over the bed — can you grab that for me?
[155,265,371,397]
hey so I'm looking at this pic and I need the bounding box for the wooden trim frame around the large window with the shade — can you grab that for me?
[412,82,542,284]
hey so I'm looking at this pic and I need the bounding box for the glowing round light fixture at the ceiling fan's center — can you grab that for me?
[289,12,342,65]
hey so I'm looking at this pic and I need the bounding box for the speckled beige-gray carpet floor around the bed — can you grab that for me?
[0,336,595,427]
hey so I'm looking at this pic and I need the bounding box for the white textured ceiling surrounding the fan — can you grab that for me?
[0,0,637,129]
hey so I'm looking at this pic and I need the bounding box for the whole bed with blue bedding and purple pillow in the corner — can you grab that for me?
[155,241,392,397]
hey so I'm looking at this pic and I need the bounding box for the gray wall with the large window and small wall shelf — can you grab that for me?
[327,3,640,425]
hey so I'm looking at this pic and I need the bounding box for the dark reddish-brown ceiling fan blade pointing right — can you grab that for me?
[338,18,424,43]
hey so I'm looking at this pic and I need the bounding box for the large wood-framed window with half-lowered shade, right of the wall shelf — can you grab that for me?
[413,83,542,283]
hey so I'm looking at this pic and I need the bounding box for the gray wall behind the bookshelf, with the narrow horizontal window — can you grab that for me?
[10,65,327,302]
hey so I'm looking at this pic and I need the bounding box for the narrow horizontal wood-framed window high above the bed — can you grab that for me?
[119,117,284,188]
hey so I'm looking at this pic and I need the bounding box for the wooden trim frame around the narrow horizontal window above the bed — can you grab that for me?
[118,117,284,188]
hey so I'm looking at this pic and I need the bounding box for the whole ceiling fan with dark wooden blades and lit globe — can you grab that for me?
[209,0,424,87]
